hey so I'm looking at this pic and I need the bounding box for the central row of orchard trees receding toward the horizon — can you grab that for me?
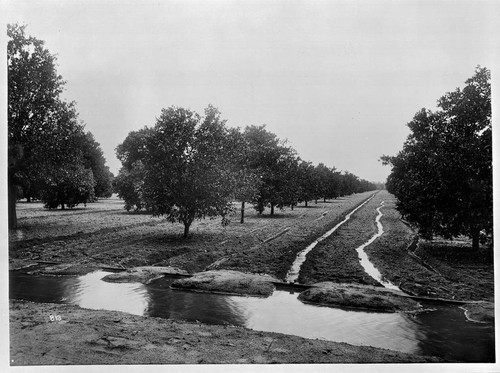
[115,106,376,237]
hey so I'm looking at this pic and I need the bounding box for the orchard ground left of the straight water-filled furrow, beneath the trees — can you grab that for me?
[9,192,373,279]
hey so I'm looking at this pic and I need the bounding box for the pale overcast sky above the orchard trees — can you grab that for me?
[7,0,500,181]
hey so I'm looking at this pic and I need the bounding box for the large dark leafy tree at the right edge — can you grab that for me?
[382,67,493,249]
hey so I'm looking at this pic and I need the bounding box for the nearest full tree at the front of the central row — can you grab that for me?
[117,106,234,237]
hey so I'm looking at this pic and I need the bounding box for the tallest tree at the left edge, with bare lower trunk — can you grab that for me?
[7,25,64,224]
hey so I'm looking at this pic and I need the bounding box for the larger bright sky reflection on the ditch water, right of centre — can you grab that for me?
[231,291,419,353]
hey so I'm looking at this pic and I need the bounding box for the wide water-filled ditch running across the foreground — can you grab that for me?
[10,271,495,362]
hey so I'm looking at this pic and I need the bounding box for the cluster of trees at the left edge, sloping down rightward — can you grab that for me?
[7,25,113,228]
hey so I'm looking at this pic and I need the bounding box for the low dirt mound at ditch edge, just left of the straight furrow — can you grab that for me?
[172,270,278,297]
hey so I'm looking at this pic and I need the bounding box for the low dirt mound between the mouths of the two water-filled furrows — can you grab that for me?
[298,282,422,312]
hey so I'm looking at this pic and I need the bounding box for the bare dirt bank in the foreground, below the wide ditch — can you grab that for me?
[10,301,442,365]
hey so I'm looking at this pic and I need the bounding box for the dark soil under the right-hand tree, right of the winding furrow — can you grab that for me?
[365,192,494,302]
